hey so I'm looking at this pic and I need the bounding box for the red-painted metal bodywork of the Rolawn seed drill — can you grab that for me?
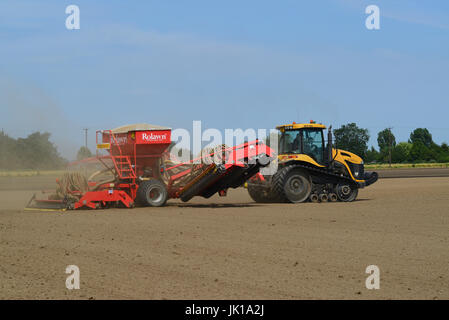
[65,130,273,209]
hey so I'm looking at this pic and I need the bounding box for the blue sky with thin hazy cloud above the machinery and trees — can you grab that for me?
[0,0,449,158]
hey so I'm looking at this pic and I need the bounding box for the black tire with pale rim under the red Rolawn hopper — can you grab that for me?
[136,179,168,207]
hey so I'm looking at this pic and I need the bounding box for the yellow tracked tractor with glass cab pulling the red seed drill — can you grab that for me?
[247,121,378,203]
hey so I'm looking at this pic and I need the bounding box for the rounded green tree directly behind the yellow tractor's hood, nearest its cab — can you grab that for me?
[334,123,369,158]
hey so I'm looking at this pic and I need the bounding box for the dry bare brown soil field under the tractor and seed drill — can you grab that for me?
[0,172,449,299]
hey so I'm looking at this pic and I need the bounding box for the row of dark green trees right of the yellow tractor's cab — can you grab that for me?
[334,123,449,163]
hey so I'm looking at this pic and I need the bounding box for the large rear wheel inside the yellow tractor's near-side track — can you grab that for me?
[273,165,312,203]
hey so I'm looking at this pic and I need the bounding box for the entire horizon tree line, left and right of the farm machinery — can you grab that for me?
[0,123,449,170]
